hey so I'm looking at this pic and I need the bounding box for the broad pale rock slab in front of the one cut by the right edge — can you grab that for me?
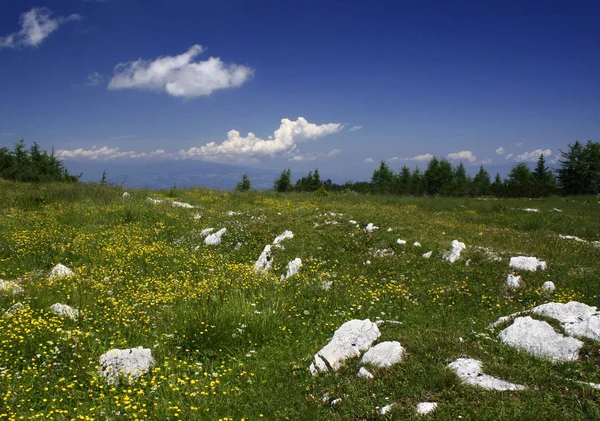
[499,316,583,362]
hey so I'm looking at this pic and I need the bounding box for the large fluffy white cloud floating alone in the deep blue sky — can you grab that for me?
[108,44,254,98]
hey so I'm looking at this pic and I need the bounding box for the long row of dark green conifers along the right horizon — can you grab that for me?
[273,140,600,197]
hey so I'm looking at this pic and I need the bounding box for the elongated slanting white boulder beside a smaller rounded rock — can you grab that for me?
[309,319,381,376]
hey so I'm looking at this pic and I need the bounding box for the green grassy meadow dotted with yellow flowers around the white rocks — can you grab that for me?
[0,183,600,420]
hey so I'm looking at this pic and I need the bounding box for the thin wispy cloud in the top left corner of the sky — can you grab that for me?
[0,7,81,48]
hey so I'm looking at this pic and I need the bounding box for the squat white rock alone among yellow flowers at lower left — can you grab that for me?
[99,347,154,384]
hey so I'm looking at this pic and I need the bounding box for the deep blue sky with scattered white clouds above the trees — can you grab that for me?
[0,0,600,179]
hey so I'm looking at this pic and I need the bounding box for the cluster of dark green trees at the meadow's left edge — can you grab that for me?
[0,139,81,182]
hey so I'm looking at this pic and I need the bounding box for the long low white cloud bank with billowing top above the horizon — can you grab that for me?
[57,117,344,162]
